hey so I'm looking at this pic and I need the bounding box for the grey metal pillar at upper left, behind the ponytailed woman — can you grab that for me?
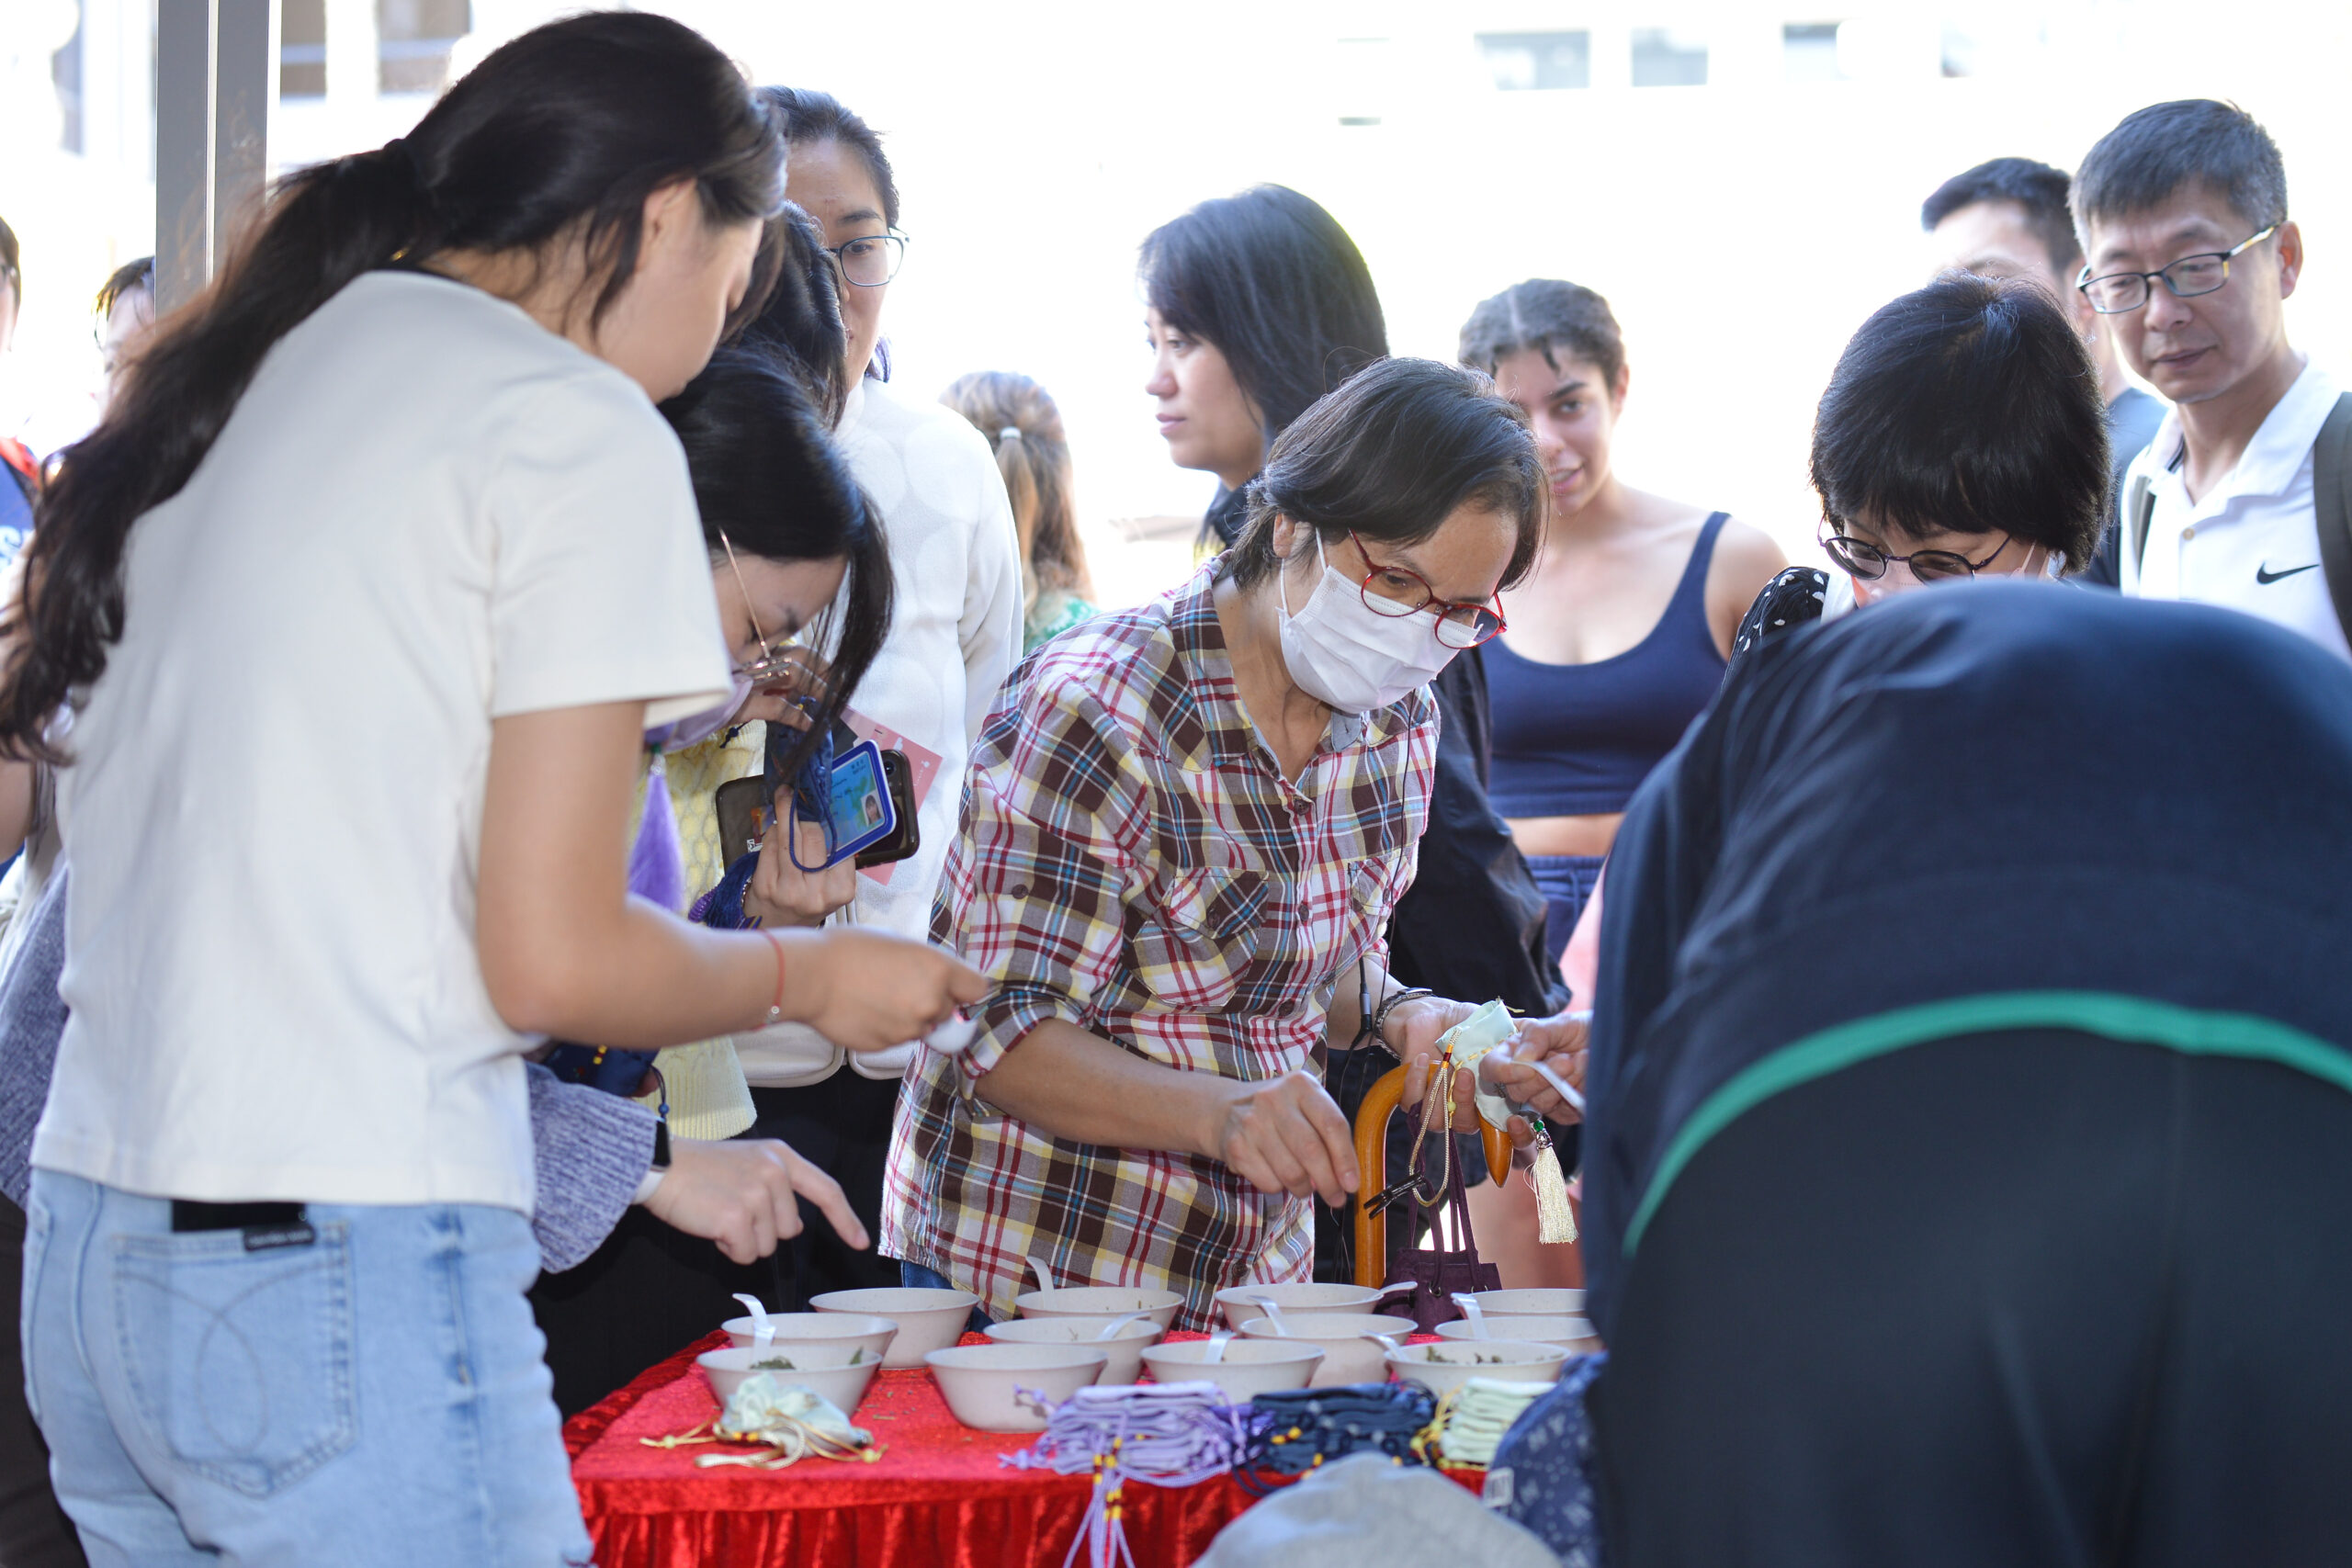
[155,0,277,315]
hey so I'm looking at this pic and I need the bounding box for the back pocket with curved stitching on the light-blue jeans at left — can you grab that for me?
[113,1223,357,1497]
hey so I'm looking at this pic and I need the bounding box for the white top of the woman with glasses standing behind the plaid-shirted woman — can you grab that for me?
[734,381,1021,1089]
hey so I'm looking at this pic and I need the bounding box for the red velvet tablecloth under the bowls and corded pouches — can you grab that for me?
[564,1333,1253,1568]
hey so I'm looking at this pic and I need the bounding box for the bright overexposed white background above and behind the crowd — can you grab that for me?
[0,0,2352,606]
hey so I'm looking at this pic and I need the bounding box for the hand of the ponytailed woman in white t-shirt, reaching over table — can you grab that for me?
[778,926,988,1051]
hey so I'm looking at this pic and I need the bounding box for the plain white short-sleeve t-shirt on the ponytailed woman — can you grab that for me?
[33,273,727,1211]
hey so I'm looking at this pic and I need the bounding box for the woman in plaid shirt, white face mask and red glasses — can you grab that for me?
[882,360,1576,1328]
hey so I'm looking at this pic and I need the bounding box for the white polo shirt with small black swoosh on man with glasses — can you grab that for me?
[2120,362,2352,659]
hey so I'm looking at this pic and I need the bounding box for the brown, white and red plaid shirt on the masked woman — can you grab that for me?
[882,562,1437,1328]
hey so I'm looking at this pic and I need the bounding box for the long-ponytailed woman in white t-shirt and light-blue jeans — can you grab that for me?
[0,12,978,1565]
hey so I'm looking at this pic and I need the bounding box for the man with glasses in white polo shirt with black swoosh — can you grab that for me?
[2072,98,2352,659]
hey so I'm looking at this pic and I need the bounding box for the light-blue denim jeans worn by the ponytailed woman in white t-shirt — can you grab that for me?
[24,1170,588,1568]
